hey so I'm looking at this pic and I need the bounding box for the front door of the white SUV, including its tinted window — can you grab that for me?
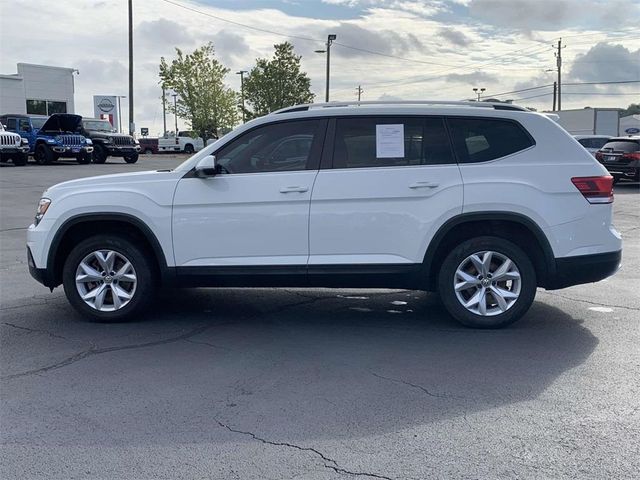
[173,119,326,271]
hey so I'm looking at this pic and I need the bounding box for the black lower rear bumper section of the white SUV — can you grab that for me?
[545,250,622,290]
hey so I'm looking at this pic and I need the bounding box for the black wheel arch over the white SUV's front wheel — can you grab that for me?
[45,213,172,288]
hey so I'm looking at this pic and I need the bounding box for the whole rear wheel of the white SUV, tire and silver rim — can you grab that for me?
[438,236,537,328]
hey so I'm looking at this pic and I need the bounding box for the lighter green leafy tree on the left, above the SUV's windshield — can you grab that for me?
[160,43,238,139]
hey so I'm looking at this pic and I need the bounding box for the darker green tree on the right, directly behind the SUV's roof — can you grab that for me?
[244,42,315,117]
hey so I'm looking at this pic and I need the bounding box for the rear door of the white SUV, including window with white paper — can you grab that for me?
[309,116,463,271]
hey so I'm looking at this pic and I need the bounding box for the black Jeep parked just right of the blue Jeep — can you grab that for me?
[80,118,140,163]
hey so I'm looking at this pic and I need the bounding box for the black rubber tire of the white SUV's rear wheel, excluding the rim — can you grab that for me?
[438,236,537,328]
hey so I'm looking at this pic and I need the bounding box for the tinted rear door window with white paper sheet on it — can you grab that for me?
[333,117,454,168]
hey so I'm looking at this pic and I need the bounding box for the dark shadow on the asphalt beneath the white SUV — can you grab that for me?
[0,289,598,445]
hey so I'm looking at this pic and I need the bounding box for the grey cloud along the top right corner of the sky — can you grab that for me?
[468,0,640,30]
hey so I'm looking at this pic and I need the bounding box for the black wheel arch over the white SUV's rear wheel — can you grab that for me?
[423,211,556,290]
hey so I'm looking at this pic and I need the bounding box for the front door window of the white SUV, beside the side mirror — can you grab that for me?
[216,120,325,173]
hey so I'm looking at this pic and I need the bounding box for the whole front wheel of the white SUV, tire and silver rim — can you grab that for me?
[62,234,157,322]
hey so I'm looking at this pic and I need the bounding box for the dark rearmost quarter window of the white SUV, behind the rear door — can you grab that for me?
[447,118,535,163]
